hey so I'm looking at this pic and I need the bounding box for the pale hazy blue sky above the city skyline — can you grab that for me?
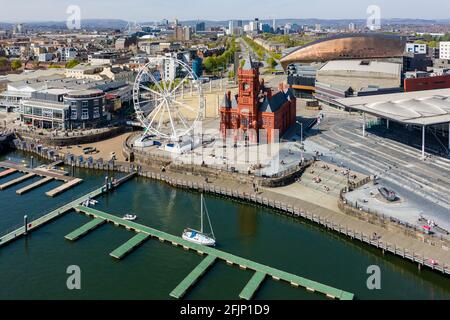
[0,0,450,22]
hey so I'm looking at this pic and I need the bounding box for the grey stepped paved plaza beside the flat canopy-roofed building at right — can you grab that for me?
[298,107,450,229]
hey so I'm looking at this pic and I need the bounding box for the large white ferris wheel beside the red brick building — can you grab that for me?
[133,57,205,142]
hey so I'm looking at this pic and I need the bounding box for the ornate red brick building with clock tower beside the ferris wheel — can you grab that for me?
[220,59,296,142]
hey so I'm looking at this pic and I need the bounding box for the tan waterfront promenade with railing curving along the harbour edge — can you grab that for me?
[7,141,450,274]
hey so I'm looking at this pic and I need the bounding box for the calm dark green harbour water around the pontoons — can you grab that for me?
[0,152,450,299]
